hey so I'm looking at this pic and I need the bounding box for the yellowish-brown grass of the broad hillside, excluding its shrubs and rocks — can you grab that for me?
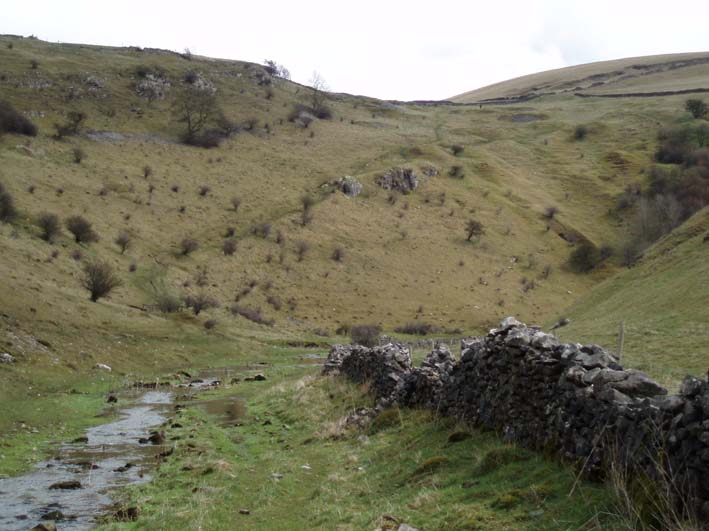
[0,34,681,386]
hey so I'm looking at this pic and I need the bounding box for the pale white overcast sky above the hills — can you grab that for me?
[5,0,709,100]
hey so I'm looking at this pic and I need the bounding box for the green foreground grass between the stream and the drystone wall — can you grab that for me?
[94,370,619,530]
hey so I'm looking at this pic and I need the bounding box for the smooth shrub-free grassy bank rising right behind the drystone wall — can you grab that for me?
[560,208,709,386]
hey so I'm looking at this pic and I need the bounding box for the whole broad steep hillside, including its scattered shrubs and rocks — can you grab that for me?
[0,36,706,390]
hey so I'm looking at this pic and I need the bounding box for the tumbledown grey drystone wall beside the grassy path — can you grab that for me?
[324,318,709,517]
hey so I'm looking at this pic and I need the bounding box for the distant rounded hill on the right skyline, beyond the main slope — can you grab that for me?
[451,53,709,103]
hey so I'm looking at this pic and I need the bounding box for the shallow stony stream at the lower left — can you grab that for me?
[0,391,172,531]
